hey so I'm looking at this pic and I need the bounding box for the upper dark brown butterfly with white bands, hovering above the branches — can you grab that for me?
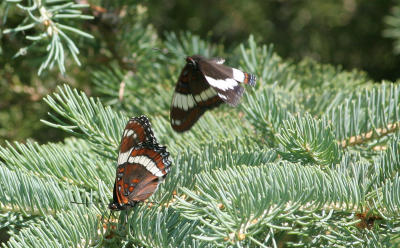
[170,55,256,132]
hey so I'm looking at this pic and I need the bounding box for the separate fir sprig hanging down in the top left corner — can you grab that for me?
[3,0,94,75]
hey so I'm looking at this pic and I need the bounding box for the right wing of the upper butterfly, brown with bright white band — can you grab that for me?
[198,59,256,106]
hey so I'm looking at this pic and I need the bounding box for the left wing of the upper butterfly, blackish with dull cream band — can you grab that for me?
[170,64,223,132]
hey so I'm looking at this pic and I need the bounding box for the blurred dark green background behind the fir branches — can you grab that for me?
[0,0,400,145]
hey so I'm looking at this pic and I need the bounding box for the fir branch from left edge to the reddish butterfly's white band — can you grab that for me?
[0,140,114,190]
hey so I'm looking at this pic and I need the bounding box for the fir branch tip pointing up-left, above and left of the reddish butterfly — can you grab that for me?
[42,85,128,157]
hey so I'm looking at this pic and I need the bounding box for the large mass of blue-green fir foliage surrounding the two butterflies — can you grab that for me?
[0,0,400,247]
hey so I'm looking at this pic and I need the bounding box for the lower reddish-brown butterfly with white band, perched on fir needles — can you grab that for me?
[108,116,171,210]
